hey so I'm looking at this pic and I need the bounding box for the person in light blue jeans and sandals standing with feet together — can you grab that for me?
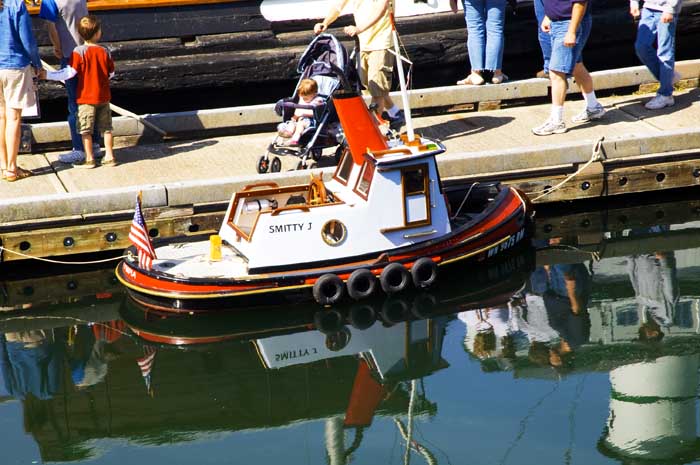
[450,0,508,86]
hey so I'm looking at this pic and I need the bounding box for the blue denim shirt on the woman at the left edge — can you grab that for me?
[0,0,41,69]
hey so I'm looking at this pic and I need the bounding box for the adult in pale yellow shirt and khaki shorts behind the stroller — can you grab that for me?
[314,0,406,131]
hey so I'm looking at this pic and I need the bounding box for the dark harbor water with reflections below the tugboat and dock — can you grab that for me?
[0,194,700,465]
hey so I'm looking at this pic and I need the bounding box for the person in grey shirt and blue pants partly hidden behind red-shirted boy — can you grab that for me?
[39,0,101,164]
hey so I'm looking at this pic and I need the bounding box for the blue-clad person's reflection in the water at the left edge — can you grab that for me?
[0,330,63,400]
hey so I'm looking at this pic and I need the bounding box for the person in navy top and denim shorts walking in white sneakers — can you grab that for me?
[532,0,605,136]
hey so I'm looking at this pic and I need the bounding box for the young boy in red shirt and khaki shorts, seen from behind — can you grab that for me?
[47,15,116,168]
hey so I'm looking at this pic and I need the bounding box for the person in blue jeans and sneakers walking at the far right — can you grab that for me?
[630,0,682,110]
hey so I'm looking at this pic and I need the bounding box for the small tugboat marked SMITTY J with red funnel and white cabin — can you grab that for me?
[117,33,533,313]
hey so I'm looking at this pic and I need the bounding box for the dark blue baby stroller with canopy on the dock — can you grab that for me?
[257,34,360,174]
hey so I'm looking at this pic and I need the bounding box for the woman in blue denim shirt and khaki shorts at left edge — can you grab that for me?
[0,0,41,182]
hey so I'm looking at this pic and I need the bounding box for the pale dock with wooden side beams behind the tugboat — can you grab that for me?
[0,60,700,261]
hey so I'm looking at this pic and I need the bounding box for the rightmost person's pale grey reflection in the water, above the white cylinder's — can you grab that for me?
[627,248,680,341]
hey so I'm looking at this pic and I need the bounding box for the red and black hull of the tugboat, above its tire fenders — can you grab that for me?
[116,188,531,313]
